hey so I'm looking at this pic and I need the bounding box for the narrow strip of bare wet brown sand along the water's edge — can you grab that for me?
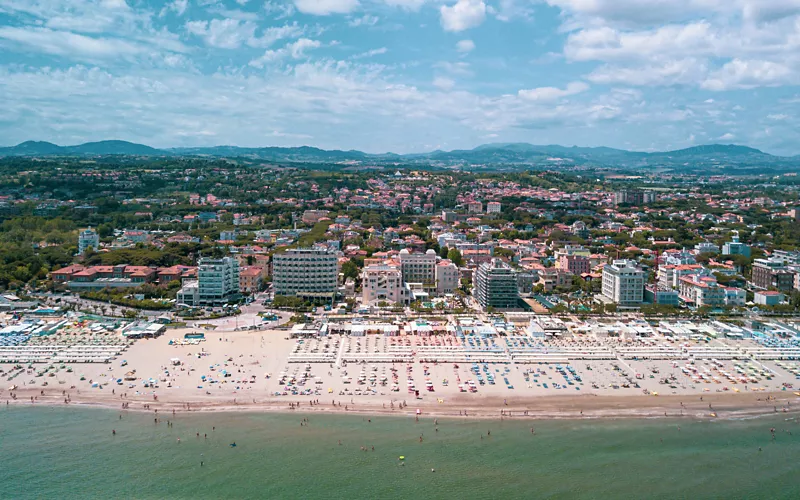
[7,389,800,420]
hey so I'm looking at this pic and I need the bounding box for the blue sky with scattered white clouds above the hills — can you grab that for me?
[0,0,800,155]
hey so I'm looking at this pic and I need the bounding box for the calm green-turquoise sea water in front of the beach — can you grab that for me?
[0,407,800,499]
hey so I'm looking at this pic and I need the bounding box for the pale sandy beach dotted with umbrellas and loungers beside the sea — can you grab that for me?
[0,329,800,418]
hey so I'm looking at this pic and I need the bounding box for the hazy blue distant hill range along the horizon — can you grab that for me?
[0,141,800,173]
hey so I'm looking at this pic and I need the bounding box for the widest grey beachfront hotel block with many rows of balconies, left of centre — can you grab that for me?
[272,248,339,298]
